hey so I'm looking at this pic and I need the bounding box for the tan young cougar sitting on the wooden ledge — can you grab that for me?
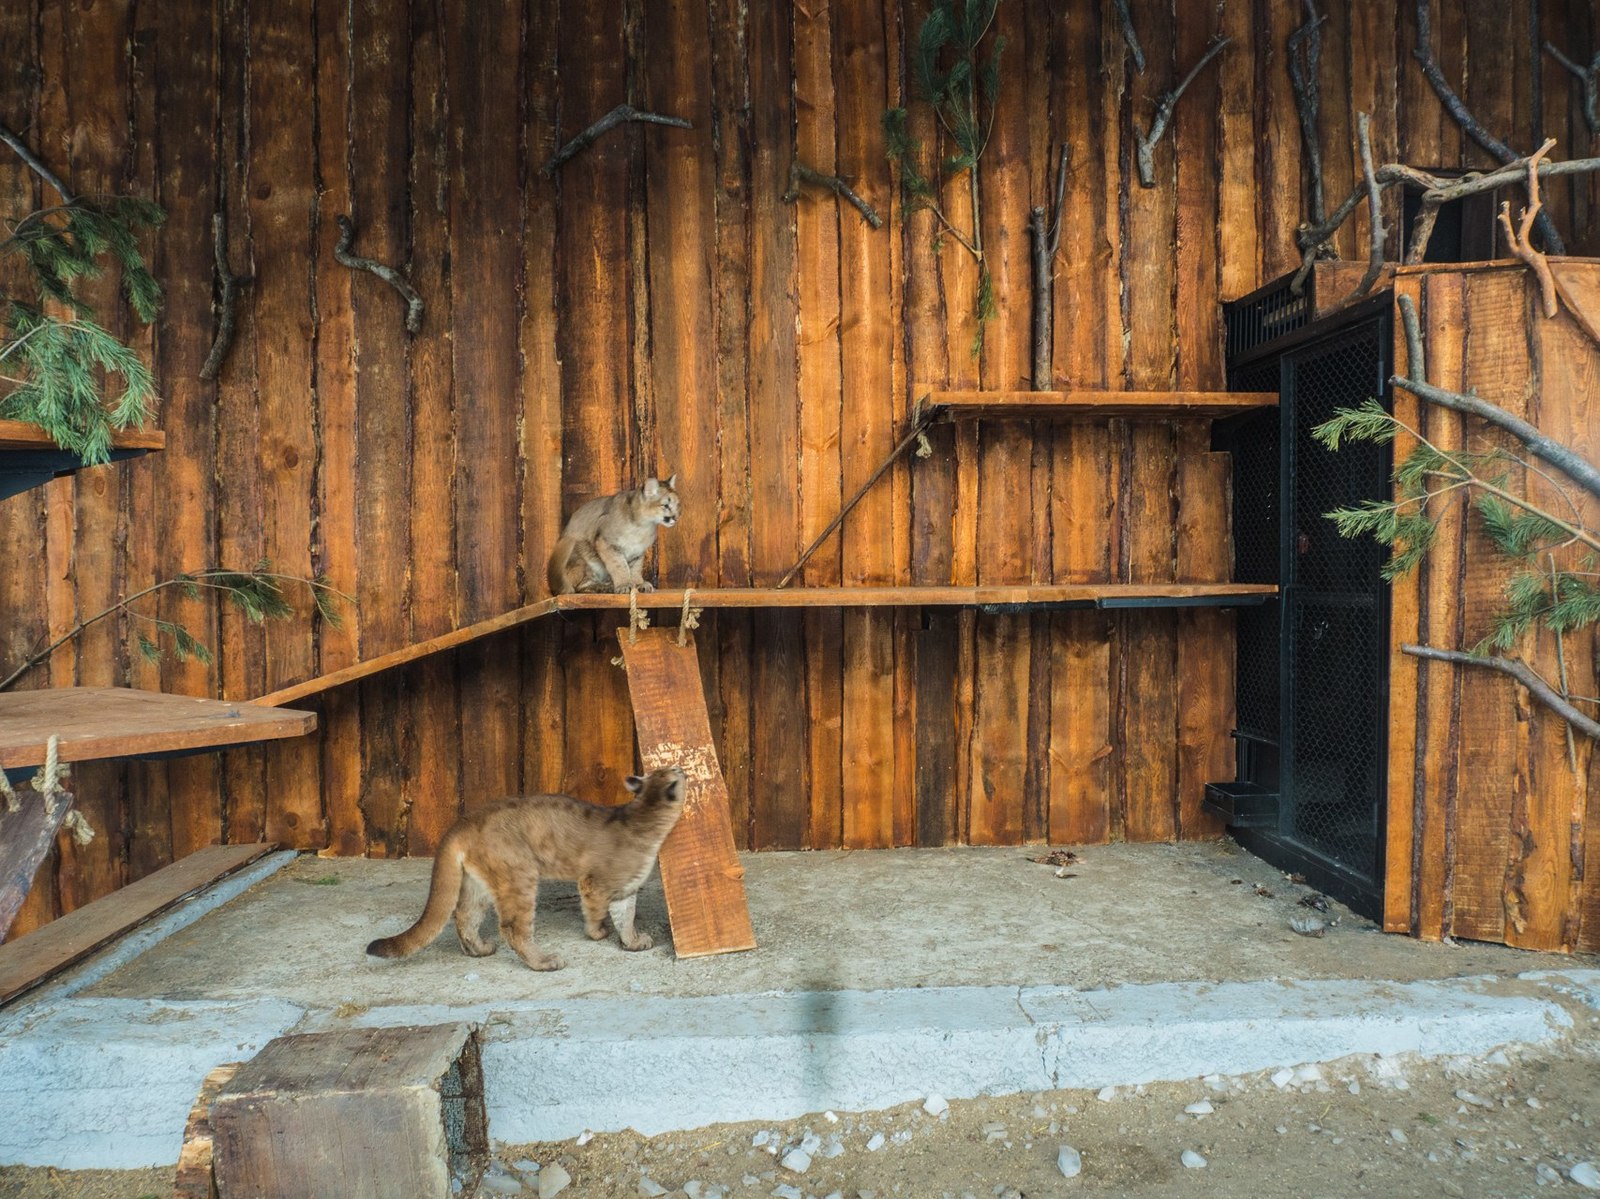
[549,475,678,595]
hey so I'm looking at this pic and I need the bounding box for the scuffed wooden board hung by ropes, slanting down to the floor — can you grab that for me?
[616,629,755,957]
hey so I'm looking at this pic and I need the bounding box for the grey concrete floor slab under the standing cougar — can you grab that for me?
[83,842,1578,1009]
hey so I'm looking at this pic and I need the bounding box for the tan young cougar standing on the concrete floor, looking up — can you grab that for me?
[366,767,683,970]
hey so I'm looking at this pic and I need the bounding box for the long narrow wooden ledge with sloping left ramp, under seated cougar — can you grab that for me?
[254,583,1278,706]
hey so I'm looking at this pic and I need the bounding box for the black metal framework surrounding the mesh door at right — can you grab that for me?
[1205,279,1392,916]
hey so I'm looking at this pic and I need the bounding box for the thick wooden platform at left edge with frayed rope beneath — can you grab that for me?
[0,687,317,768]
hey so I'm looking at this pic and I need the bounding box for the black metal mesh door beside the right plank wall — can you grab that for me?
[1277,317,1389,898]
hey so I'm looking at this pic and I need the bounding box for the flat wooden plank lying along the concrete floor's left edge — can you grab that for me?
[0,844,274,1004]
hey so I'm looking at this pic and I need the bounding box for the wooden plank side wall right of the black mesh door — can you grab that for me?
[1384,263,1600,951]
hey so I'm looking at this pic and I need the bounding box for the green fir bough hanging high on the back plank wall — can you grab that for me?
[883,0,1005,359]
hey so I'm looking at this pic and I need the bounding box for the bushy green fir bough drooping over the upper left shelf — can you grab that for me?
[0,197,165,464]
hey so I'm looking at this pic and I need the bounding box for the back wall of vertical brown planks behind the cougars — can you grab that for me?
[0,0,1595,925]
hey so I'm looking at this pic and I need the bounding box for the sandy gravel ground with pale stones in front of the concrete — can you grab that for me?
[0,1025,1600,1199]
